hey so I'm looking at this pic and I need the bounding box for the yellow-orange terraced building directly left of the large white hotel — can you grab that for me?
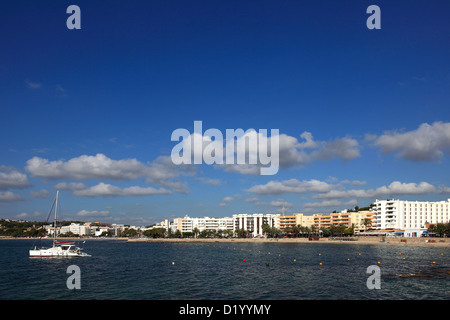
[313,210,375,233]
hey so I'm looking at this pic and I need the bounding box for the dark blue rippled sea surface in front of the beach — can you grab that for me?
[0,239,450,300]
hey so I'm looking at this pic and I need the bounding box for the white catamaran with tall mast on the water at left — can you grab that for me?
[30,191,90,257]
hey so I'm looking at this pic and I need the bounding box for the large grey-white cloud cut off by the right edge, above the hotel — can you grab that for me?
[374,121,450,161]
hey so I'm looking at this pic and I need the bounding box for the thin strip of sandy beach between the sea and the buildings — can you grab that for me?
[0,237,450,247]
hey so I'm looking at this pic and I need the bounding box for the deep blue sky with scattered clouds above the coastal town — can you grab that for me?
[0,0,450,225]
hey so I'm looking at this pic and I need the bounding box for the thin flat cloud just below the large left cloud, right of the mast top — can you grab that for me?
[73,182,172,197]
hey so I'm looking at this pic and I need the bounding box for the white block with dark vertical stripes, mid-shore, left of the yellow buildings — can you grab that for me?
[233,213,280,237]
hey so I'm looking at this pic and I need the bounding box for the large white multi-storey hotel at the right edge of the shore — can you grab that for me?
[373,199,450,230]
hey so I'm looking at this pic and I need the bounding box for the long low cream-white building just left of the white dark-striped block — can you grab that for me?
[172,215,233,233]
